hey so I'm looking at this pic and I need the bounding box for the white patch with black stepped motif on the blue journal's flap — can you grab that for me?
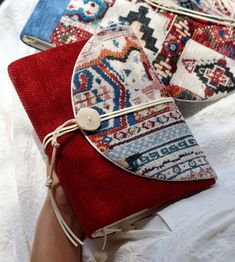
[100,0,172,60]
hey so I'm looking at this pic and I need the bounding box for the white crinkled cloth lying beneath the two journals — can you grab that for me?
[0,0,235,262]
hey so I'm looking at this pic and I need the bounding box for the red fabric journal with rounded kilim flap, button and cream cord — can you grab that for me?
[9,24,216,253]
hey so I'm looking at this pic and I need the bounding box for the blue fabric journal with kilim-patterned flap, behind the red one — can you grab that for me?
[21,0,235,101]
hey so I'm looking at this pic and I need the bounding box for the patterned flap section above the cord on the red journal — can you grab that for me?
[73,24,164,115]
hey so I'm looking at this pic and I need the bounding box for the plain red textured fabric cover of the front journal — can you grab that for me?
[9,41,215,237]
